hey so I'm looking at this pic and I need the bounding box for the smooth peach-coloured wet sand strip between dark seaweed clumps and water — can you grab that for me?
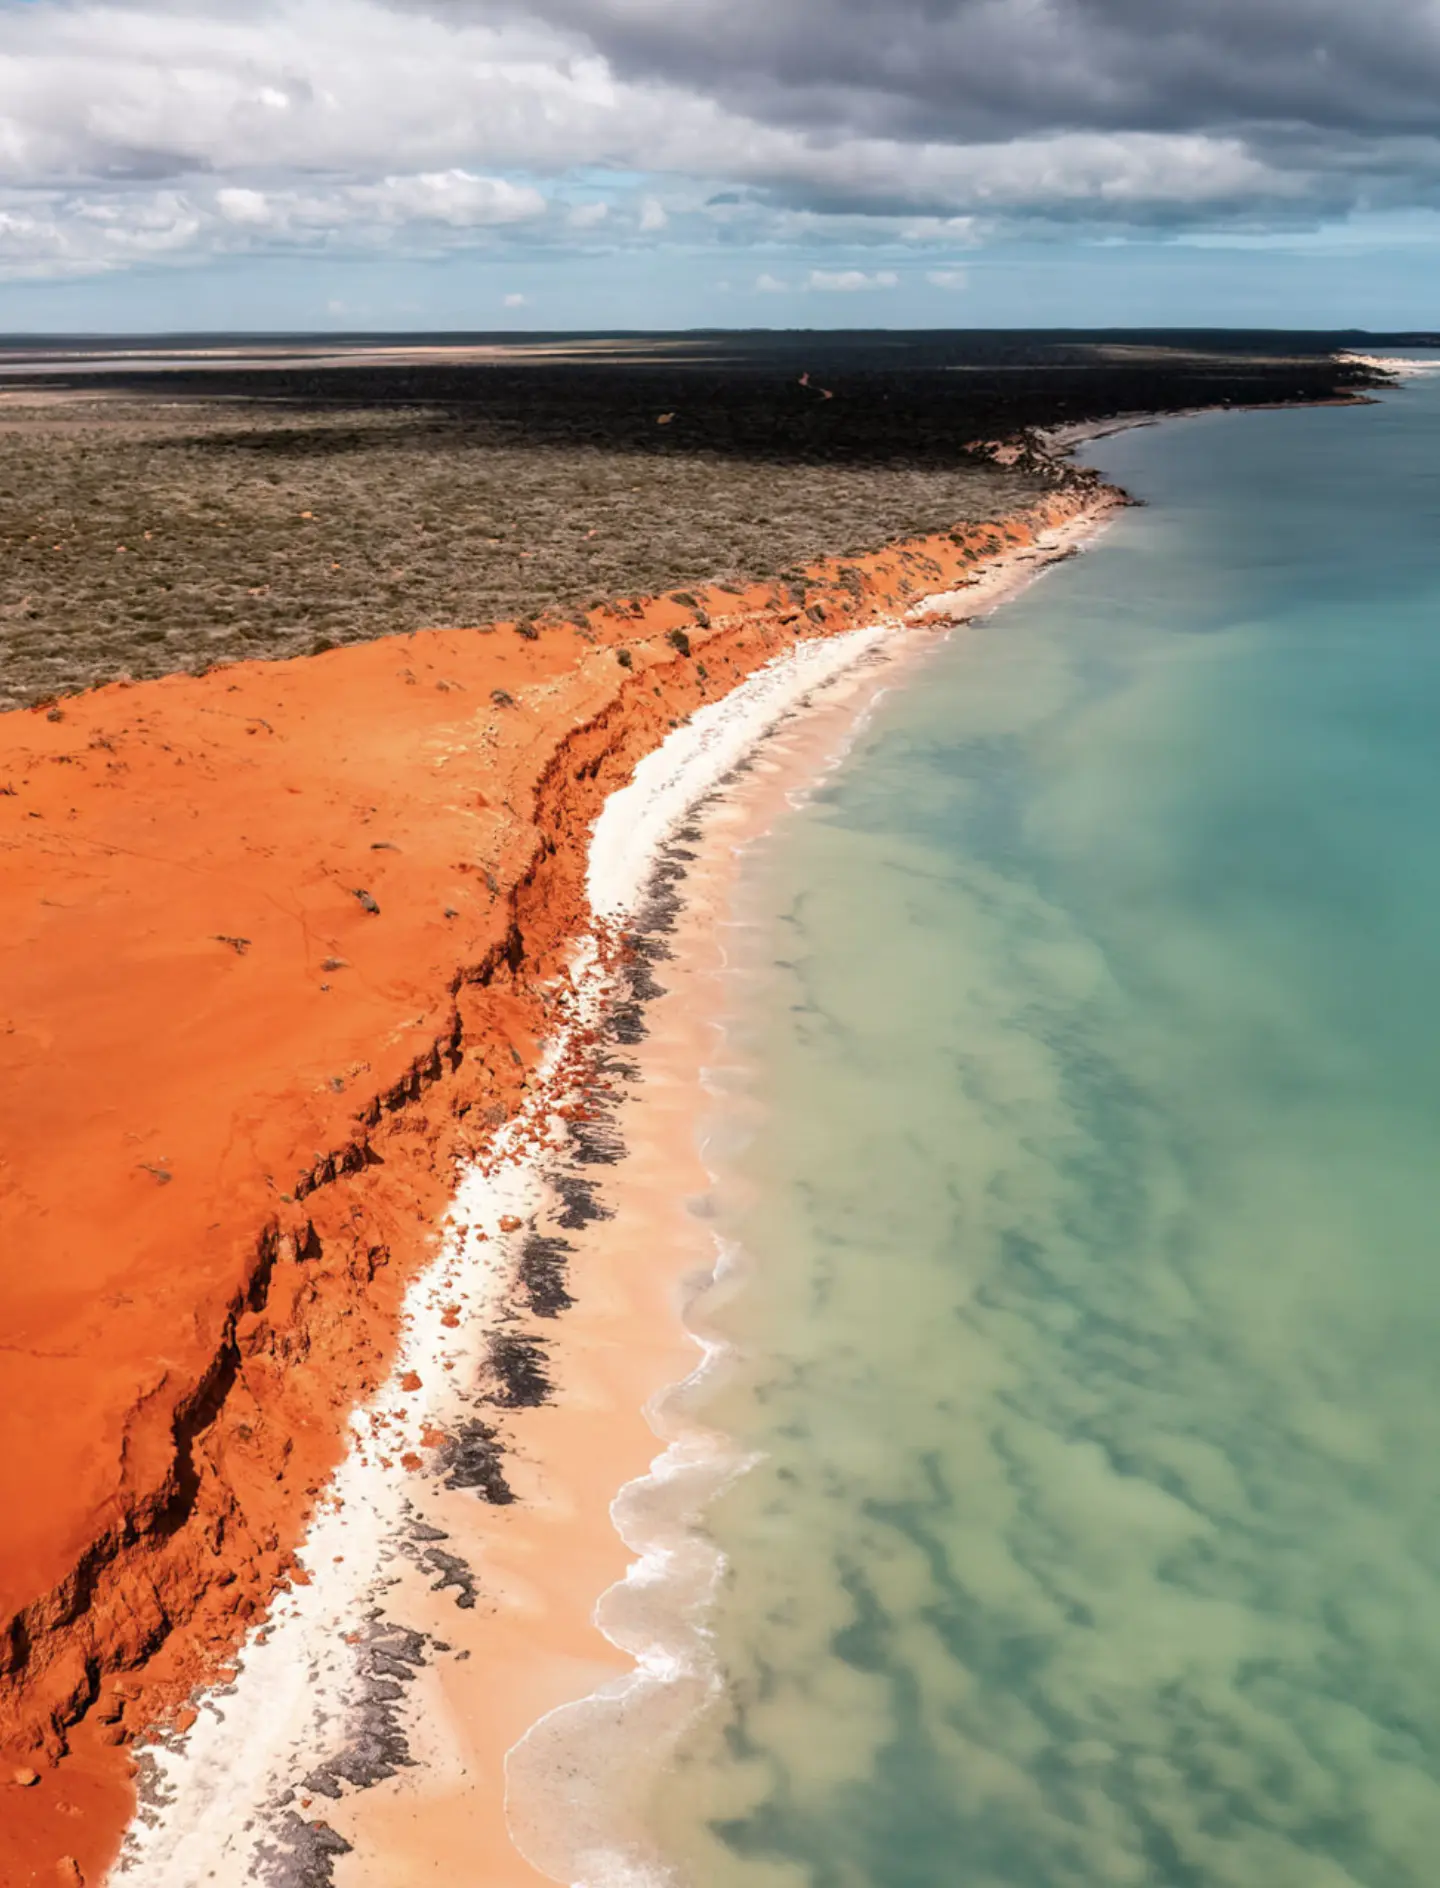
[328,659,924,1888]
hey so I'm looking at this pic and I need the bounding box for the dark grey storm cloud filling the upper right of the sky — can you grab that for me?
[502,0,1440,142]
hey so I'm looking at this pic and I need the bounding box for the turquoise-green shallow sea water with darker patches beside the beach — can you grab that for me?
[655,379,1440,1888]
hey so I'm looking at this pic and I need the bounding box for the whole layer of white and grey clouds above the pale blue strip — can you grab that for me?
[0,0,1440,285]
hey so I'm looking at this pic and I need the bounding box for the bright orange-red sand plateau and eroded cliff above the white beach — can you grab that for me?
[0,495,1091,1888]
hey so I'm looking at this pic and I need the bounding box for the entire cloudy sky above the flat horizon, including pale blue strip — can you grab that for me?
[0,0,1440,334]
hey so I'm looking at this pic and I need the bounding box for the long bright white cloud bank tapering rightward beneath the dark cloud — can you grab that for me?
[0,0,1321,221]
